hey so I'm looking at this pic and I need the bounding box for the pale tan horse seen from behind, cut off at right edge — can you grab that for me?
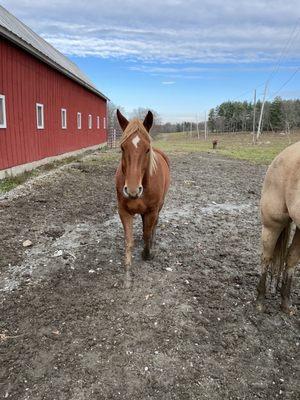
[257,142,300,314]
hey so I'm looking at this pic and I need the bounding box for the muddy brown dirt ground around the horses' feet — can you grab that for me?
[0,153,300,400]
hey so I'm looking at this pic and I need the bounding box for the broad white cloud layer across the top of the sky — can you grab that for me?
[2,0,300,64]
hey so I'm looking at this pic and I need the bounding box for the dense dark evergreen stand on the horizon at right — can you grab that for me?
[208,97,300,132]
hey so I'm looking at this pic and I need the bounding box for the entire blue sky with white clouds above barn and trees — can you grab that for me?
[0,0,300,122]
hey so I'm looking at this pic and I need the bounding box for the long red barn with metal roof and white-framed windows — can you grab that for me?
[0,6,108,178]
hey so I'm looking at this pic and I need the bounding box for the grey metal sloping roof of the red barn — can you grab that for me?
[0,5,108,100]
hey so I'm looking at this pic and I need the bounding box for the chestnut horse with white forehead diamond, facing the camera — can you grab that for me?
[116,110,170,286]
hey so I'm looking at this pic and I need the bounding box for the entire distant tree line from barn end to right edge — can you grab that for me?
[108,97,300,137]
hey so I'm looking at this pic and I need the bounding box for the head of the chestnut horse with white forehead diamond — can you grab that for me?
[117,110,155,199]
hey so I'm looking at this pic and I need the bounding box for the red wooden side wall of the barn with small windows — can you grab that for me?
[0,38,106,170]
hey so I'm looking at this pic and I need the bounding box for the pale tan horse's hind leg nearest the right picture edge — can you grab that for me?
[281,228,300,314]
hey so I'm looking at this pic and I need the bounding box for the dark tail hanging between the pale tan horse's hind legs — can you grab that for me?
[270,222,291,288]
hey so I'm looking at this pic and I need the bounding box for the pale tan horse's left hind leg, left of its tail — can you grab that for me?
[256,225,283,311]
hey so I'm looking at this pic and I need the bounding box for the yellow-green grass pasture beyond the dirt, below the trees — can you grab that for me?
[154,132,300,164]
